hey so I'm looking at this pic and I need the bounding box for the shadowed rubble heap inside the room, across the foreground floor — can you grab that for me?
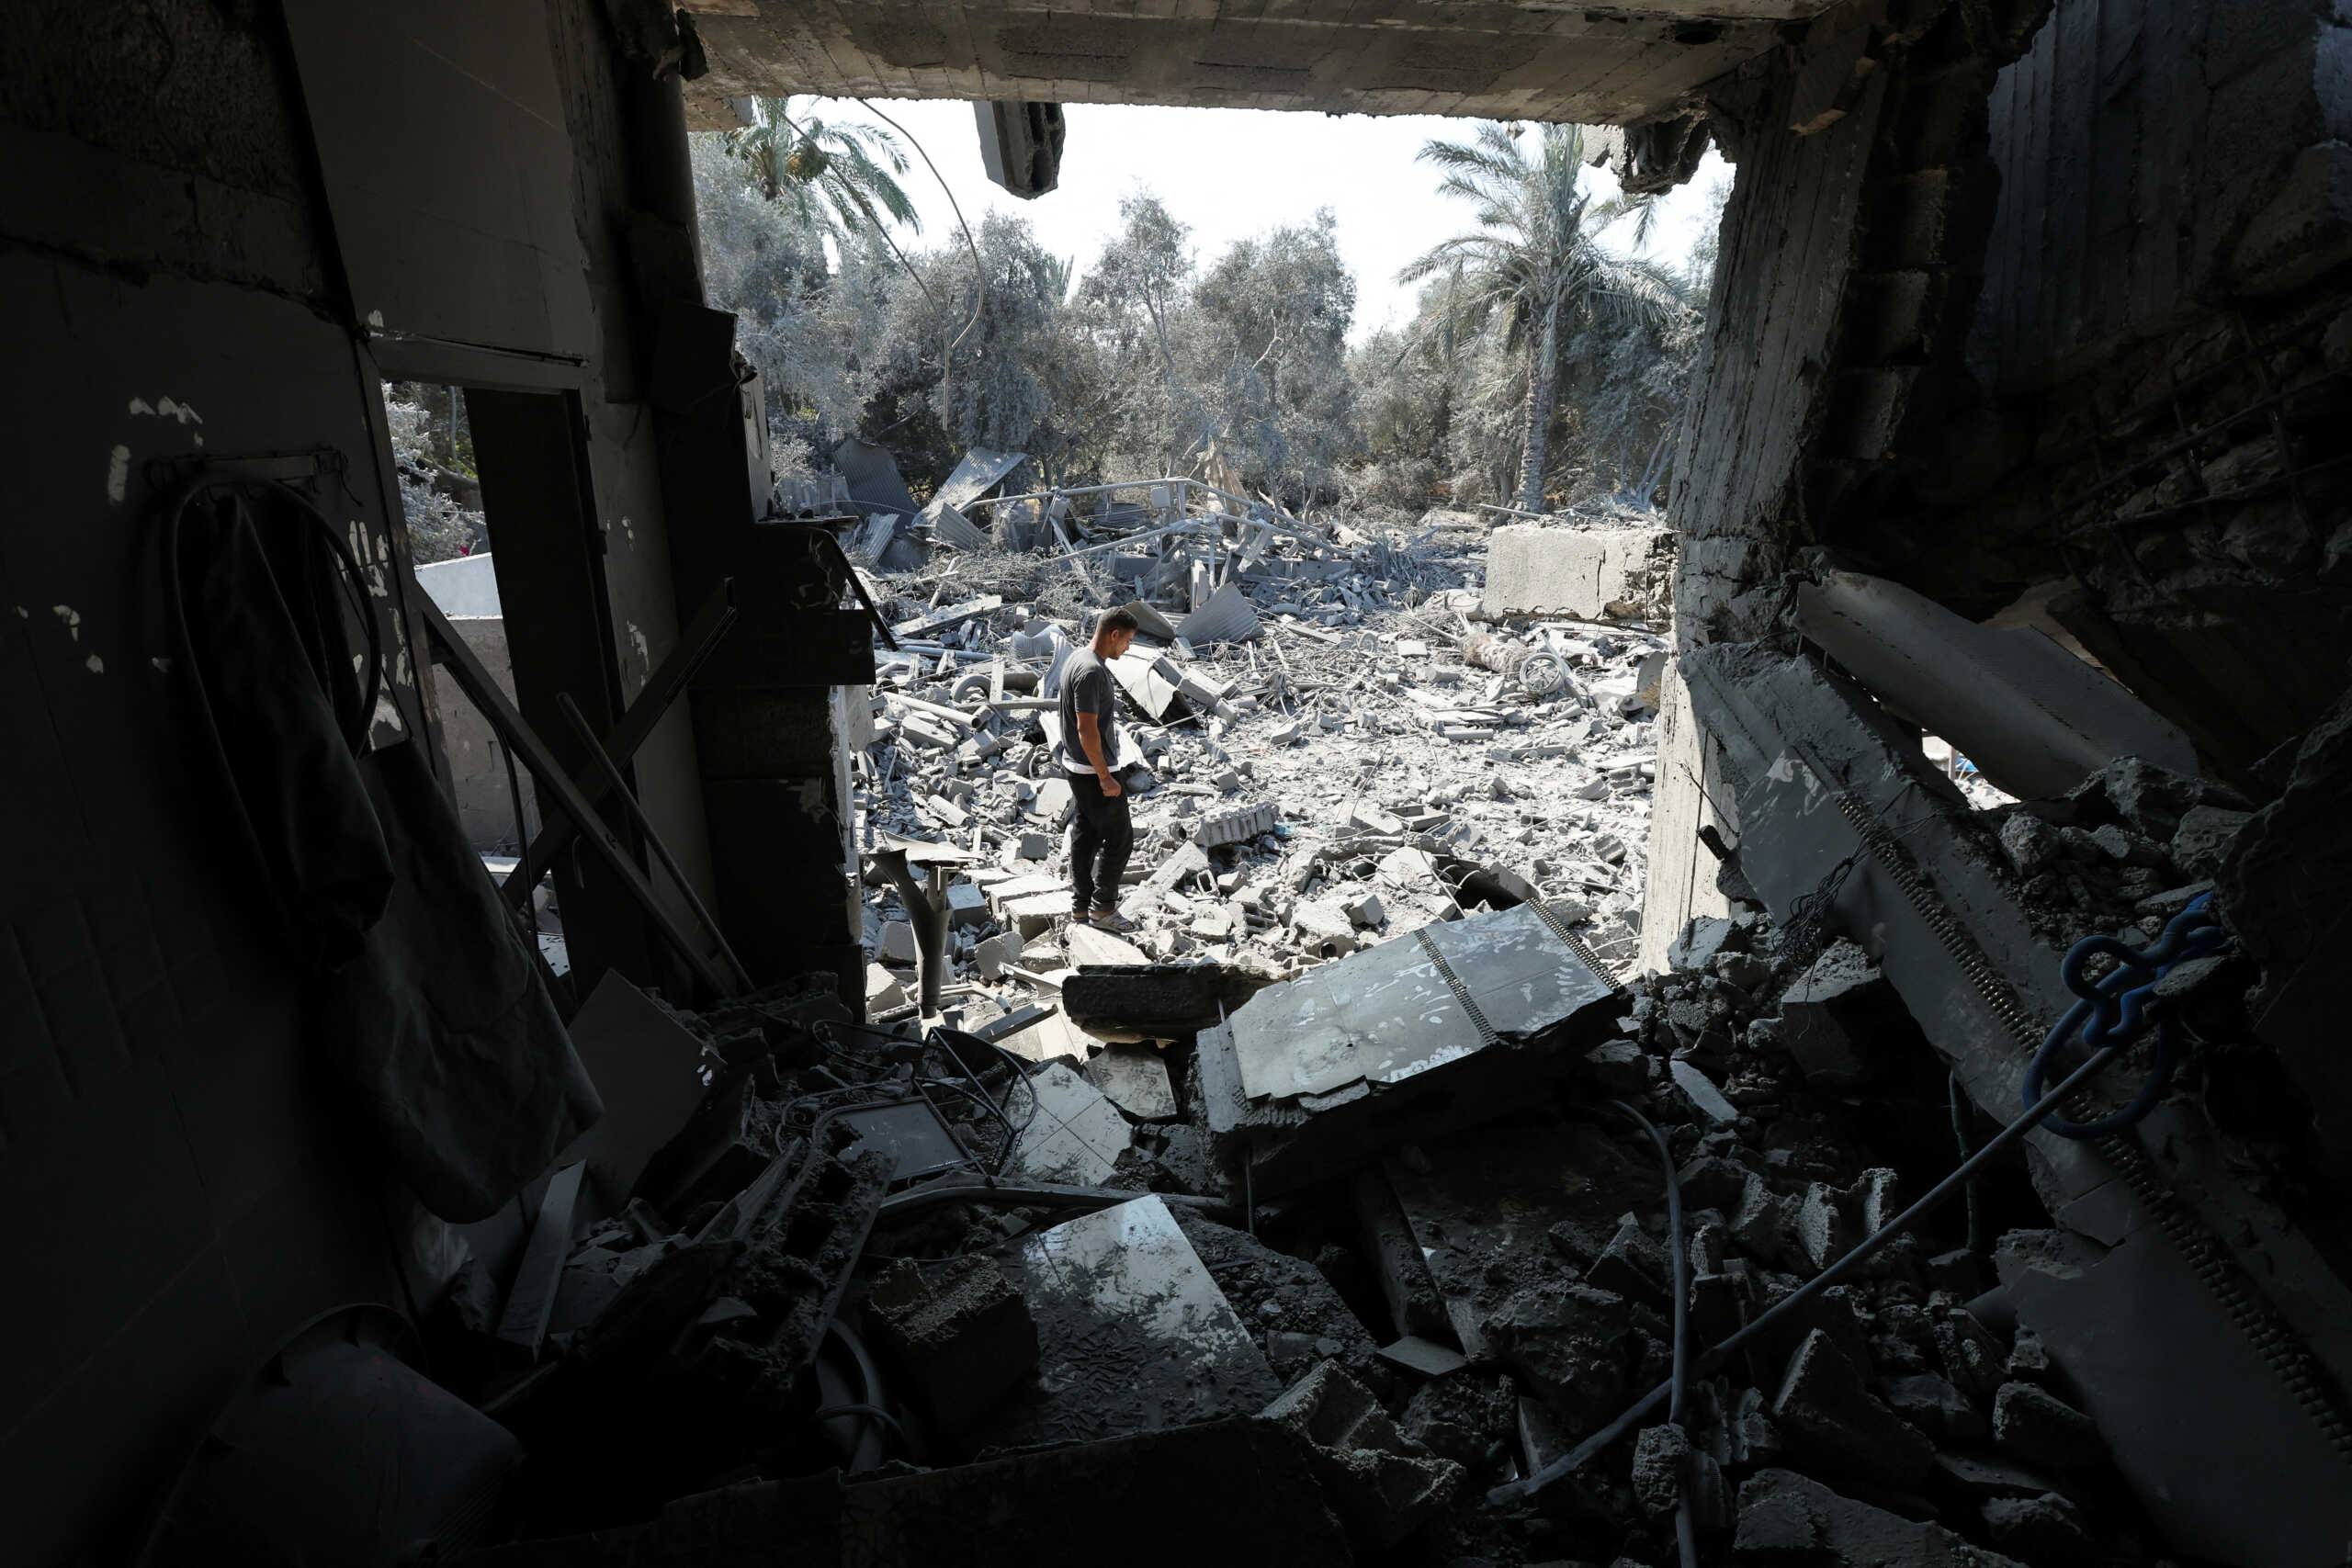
[440,879,2220,1568]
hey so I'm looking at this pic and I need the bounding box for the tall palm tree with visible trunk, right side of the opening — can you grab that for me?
[1397,122,1679,513]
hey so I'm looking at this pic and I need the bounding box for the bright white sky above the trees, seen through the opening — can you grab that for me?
[790,98,1731,341]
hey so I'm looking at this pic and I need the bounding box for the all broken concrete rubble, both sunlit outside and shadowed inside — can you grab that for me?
[303,491,2347,1568]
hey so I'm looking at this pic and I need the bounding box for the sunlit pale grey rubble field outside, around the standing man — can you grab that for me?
[856,486,1665,1016]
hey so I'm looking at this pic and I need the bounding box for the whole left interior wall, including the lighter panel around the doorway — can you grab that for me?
[0,0,738,1563]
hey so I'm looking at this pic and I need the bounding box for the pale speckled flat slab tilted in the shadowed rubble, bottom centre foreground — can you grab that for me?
[988,1194,1280,1448]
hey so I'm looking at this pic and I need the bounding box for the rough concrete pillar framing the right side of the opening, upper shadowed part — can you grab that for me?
[1672,0,2041,642]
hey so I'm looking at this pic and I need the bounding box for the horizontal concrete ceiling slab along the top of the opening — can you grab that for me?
[687,0,1835,130]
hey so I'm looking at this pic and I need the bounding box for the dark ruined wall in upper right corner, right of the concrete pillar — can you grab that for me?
[1868,0,2352,795]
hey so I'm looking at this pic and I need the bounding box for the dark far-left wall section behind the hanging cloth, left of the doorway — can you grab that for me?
[0,3,398,1563]
